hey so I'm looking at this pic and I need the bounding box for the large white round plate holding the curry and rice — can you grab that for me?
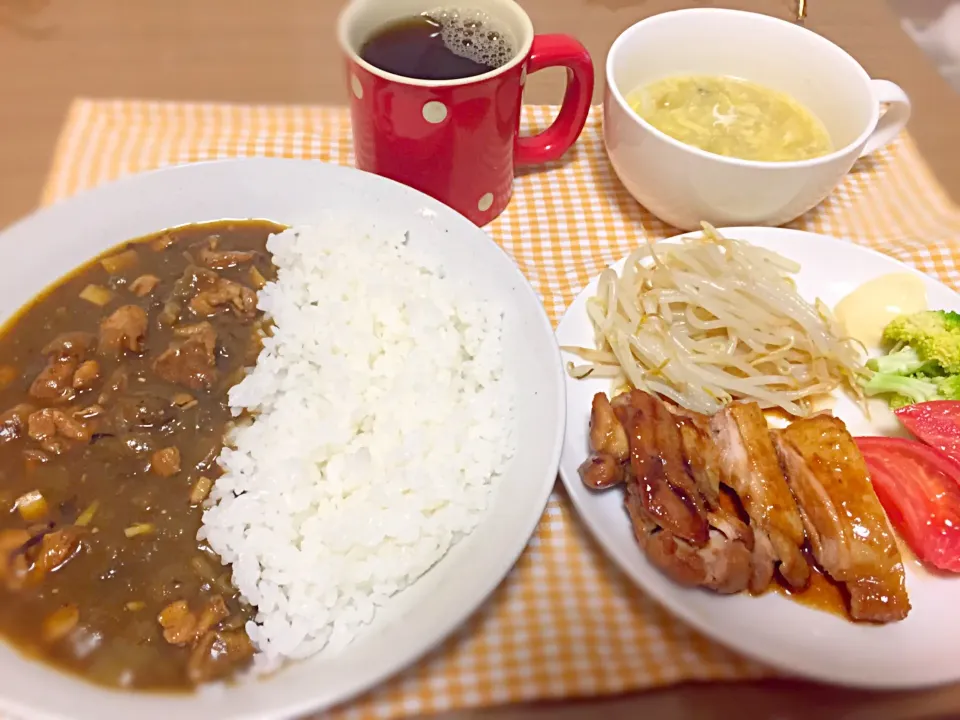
[0,159,564,720]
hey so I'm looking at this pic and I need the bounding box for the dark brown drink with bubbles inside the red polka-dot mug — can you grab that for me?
[360,8,516,80]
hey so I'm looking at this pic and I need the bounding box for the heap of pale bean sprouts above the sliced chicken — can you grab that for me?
[564,223,866,416]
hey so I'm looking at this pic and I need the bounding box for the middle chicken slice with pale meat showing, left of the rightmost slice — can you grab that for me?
[711,403,810,593]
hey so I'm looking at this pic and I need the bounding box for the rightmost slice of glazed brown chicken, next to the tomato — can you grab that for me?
[775,415,910,623]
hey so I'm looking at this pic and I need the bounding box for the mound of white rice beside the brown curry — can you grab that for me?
[199,227,514,670]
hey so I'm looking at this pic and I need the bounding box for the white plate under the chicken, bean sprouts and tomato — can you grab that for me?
[557,227,960,689]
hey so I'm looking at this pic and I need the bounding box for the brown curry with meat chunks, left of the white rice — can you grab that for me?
[0,221,282,690]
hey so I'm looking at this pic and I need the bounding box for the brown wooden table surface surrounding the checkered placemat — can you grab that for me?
[0,0,960,720]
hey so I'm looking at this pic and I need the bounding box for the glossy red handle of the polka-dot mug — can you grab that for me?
[515,35,593,164]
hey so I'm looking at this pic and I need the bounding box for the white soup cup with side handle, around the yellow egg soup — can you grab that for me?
[603,8,910,230]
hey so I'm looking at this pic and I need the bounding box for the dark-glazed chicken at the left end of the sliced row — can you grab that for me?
[580,391,753,593]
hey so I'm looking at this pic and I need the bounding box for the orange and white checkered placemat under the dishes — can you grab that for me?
[43,100,960,718]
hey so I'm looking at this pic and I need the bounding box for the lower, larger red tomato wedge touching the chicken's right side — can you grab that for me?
[856,437,960,572]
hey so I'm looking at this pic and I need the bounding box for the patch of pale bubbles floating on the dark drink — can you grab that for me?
[424,8,515,69]
